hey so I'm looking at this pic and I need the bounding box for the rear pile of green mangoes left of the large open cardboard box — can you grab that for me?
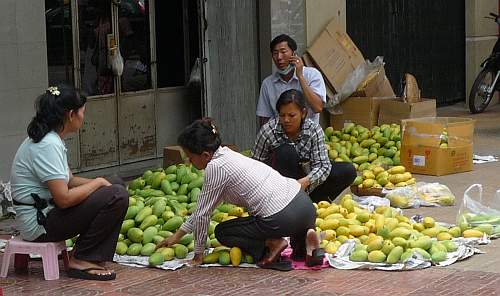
[324,123,401,171]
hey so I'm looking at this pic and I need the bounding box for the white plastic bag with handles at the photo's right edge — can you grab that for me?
[457,184,500,238]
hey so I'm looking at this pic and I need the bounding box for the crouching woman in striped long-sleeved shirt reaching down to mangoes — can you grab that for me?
[158,119,324,270]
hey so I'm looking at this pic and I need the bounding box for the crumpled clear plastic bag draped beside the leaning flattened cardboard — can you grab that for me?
[325,56,384,115]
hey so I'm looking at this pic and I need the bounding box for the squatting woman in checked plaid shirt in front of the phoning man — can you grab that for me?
[252,89,356,202]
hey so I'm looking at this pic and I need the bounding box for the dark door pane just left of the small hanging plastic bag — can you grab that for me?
[78,0,115,96]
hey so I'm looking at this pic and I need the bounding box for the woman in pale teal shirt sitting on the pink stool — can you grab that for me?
[11,85,128,280]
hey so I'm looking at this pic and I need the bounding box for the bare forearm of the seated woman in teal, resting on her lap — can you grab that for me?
[47,177,111,209]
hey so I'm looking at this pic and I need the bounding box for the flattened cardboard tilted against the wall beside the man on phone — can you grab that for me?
[307,19,365,90]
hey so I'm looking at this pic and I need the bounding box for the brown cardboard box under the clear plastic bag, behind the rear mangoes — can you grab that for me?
[330,97,392,130]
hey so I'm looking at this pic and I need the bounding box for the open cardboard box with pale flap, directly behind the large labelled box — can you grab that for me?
[378,99,436,125]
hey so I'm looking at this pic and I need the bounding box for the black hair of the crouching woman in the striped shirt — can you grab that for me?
[177,117,221,154]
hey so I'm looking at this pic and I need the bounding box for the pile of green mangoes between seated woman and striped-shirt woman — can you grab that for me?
[116,164,252,265]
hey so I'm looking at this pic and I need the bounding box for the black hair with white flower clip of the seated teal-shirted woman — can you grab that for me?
[27,84,87,143]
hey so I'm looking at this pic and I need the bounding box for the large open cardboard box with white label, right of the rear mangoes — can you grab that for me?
[401,117,474,176]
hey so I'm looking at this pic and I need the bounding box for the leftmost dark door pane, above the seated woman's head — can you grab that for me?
[45,0,73,85]
